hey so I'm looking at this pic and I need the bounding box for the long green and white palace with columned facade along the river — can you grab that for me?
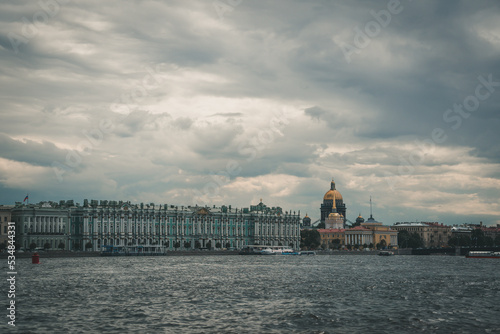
[12,200,301,251]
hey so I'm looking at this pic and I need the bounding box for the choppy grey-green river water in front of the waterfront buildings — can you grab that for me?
[0,255,500,333]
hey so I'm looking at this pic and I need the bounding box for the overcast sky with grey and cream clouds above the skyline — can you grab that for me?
[0,0,500,225]
